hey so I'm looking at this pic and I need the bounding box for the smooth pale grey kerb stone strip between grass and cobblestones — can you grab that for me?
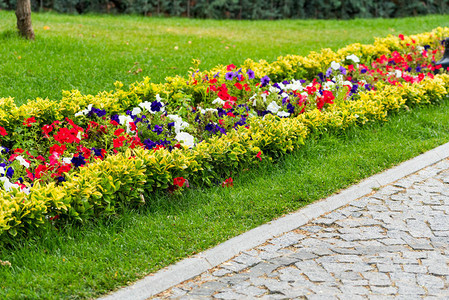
[100,143,449,300]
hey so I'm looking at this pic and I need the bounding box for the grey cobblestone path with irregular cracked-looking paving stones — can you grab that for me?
[156,160,449,300]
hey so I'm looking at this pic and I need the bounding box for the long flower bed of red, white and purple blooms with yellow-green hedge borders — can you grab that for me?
[0,28,449,237]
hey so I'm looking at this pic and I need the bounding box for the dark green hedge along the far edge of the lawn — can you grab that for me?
[0,0,449,20]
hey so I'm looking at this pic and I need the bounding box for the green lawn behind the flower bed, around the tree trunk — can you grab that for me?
[0,11,449,104]
